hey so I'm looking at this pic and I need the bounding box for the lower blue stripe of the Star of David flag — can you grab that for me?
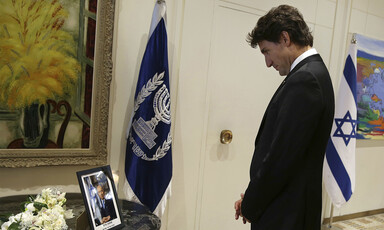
[326,139,352,201]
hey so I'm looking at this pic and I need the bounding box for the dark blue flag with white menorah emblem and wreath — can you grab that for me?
[124,1,172,217]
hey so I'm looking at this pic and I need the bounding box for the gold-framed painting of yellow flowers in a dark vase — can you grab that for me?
[0,0,115,167]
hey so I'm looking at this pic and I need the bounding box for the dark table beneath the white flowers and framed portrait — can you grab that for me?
[0,193,161,230]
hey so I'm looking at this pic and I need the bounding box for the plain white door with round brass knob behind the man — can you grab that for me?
[198,1,283,230]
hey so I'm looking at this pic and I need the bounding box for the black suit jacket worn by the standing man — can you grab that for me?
[241,54,334,230]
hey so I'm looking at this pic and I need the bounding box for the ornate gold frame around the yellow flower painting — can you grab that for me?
[0,0,115,167]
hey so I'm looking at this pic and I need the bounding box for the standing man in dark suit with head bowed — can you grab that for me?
[235,5,334,230]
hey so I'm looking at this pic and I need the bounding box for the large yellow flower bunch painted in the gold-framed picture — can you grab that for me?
[0,0,80,109]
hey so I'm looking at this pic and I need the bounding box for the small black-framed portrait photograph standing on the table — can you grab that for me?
[77,165,124,230]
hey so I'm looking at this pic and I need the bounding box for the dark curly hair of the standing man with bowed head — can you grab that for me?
[247,5,313,48]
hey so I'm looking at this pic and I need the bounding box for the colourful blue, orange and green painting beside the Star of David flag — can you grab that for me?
[356,34,384,140]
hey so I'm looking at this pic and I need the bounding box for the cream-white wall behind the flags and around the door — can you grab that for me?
[0,0,384,230]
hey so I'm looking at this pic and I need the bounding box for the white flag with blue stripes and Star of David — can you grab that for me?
[323,38,357,208]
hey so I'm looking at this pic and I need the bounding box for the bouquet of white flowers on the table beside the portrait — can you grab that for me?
[1,188,73,230]
